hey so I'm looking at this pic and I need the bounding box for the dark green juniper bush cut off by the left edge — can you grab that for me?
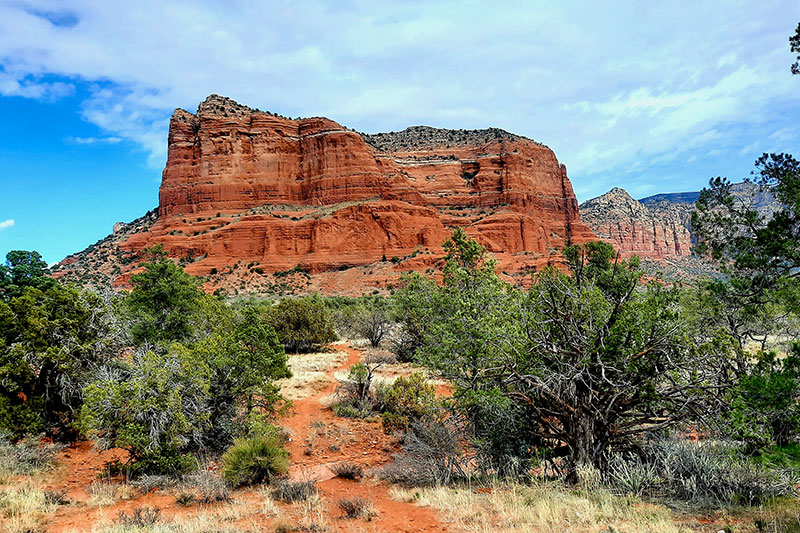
[0,270,108,436]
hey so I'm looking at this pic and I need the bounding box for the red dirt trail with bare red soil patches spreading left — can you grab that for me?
[36,345,451,533]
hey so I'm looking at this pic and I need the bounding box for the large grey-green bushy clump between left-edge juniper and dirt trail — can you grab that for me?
[82,270,290,475]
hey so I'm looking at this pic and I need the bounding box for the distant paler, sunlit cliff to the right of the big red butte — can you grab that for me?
[580,187,694,261]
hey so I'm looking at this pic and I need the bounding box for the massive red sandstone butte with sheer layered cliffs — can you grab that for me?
[54,95,594,294]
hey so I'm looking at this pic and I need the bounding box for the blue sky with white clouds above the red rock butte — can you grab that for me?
[0,0,800,262]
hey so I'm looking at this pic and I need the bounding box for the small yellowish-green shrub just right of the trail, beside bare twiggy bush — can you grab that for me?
[382,372,436,433]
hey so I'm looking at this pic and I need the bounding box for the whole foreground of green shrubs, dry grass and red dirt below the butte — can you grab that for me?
[0,31,800,532]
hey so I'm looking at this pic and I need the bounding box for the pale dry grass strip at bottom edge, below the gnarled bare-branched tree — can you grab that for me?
[390,483,689,533]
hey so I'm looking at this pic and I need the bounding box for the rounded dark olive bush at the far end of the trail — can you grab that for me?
[265,298,336,352]
